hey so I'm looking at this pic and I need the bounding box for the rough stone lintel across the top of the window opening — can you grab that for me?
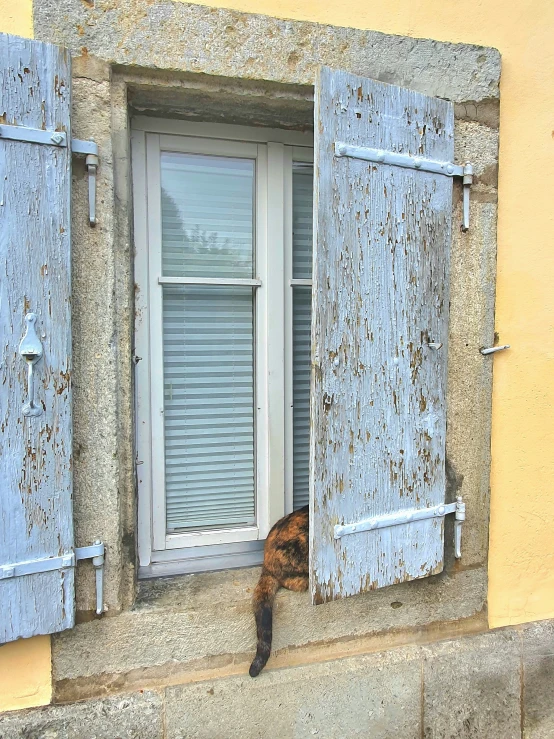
[33,0,500,102]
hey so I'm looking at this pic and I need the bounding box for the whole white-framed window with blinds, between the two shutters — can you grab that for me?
[133,119,313,570]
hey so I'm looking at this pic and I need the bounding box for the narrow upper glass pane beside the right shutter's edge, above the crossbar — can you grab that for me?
[292,164,314,280]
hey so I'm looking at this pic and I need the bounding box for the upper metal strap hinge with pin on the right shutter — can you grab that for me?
[335,141,473,231]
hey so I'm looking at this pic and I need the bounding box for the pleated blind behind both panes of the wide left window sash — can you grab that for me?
[161,152,256,532]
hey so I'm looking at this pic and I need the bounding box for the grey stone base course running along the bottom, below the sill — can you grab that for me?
[0,622,554,739]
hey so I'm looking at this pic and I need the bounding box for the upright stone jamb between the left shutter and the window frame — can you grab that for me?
[71,68,121,611]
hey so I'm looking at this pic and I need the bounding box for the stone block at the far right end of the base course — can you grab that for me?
[522,621,554,739]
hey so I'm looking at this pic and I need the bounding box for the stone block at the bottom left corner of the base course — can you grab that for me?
[0,691,163,739]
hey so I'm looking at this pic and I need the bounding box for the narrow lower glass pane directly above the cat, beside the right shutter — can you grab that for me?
[292,287,312,509]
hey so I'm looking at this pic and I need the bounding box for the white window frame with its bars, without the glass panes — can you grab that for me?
[131,116,313,574]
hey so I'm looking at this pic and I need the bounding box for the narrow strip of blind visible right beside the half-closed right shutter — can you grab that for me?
[292,165,313,509]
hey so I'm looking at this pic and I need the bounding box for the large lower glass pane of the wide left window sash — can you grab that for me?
[163,285,255,532]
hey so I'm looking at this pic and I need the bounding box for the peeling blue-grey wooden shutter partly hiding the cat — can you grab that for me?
[310,69,454,603]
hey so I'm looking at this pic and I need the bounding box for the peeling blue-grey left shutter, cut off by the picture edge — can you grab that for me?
[0,35,74,643]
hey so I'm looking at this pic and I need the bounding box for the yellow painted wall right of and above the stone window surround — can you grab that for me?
[180,0,554,627]
